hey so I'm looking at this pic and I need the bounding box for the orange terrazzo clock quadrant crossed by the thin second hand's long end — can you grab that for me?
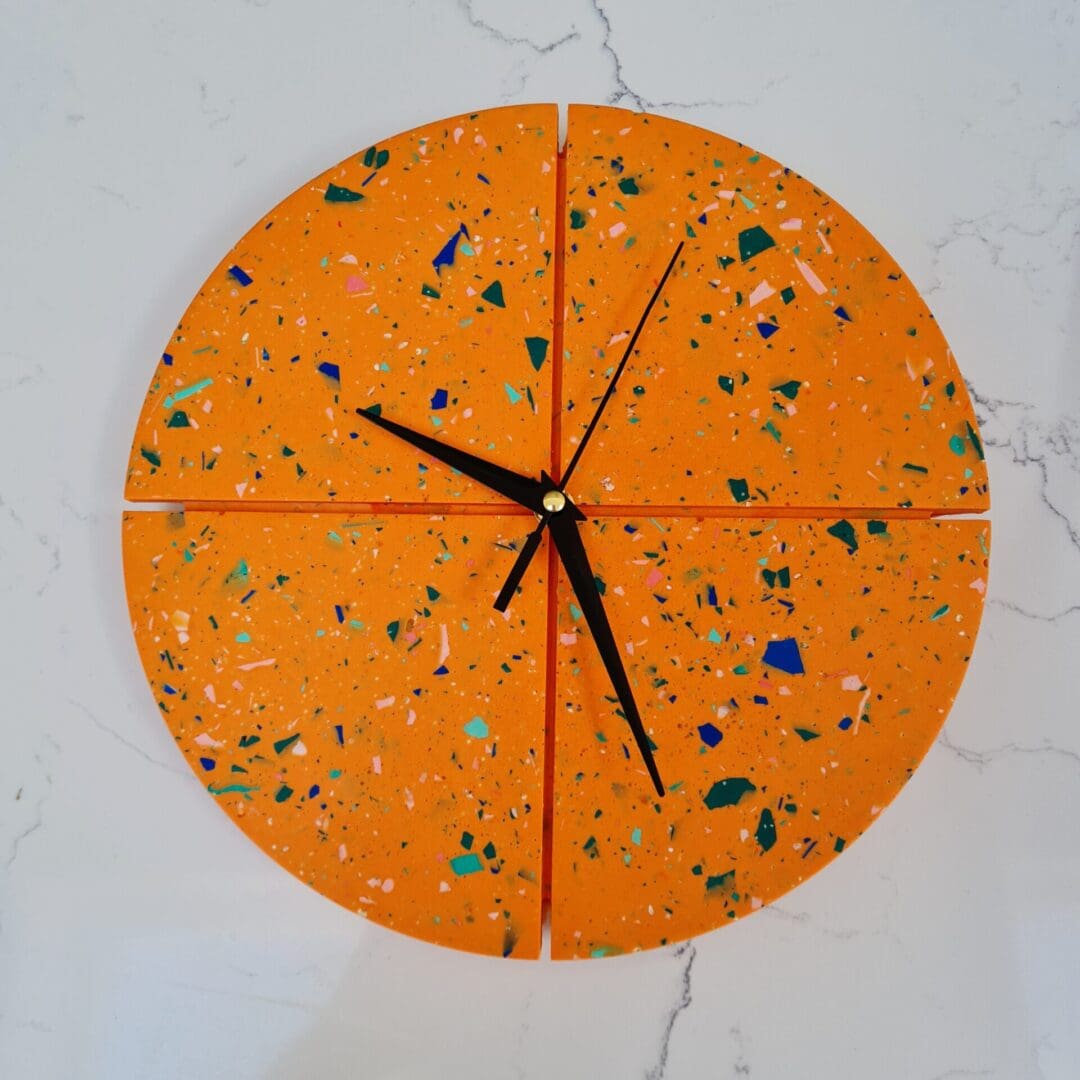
[562,106,987,512]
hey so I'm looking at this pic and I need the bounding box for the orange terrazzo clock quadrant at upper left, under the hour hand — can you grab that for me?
[125,106,557,504]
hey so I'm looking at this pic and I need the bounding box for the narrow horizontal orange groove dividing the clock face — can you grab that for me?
[122,500,978,521]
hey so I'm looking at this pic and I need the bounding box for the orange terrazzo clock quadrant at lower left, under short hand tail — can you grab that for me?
[123,512,545,957]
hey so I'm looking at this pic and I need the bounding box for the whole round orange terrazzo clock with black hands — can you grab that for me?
[123,106,988,958]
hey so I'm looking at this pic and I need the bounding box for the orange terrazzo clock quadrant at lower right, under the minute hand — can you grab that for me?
[551,513,989,958]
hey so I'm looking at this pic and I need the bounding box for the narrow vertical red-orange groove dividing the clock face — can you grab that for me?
[540,146,566,946]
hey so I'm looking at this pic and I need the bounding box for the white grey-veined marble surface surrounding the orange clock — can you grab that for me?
[0,0,1080,1080]
